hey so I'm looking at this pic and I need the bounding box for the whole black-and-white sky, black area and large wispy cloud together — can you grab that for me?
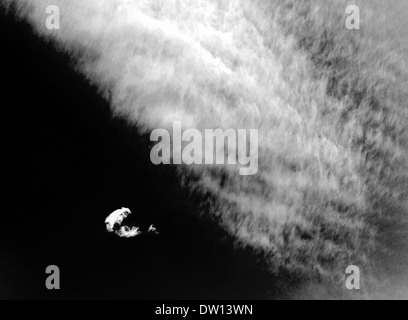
[0,0,408,299]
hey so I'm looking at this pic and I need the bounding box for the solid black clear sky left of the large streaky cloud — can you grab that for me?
[0,8,285,299]
